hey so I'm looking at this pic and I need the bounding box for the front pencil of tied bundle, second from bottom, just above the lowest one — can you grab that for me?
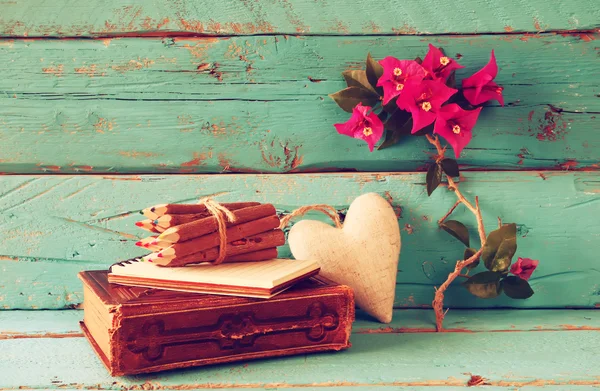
[158,216,279,257]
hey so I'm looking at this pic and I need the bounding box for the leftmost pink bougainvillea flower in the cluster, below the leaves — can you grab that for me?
[333,103,383,152]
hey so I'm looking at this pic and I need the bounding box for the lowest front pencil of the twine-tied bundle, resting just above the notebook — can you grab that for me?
[151,229,285,267]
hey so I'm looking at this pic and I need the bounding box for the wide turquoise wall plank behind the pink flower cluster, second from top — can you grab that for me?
[0,34,600,174]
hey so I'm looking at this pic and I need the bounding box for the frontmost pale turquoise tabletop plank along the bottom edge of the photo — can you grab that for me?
[0,331,600,390]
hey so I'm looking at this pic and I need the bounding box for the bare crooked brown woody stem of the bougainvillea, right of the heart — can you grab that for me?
[427,135,486,331]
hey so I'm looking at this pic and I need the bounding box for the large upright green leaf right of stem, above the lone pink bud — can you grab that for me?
[481,223,517,272]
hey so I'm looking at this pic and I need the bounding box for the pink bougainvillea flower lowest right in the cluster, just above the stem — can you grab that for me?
[433,103,482,159]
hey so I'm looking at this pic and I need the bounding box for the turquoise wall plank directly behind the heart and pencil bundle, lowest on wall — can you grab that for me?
[0,172,600,309]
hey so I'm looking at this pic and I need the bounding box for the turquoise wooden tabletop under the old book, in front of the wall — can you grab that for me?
[0,310,600,391]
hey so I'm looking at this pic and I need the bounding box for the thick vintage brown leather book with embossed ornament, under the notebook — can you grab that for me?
[79,271,354,376]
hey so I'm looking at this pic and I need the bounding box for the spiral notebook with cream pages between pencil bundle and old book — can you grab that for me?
[108,258,319,299]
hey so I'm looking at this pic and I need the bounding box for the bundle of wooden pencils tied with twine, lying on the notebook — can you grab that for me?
[136,202,285,266]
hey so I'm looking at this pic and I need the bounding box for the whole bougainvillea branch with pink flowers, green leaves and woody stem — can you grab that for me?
[330,45,538,331]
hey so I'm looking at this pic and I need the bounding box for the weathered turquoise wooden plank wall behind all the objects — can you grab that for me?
[0,0,600,309]
